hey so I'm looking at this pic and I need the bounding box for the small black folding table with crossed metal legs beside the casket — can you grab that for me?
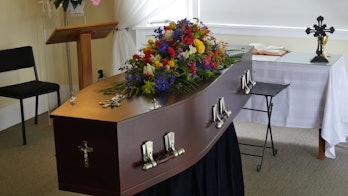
[239,82,290,172]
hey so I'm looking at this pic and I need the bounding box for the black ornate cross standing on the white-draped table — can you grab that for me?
[306,16,335,63]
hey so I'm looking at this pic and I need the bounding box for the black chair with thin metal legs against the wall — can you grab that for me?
[0,46,60,145]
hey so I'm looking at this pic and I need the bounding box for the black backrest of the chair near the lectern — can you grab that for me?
[0,46,38,80]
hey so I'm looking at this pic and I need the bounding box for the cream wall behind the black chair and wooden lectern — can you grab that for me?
[0,0,114,132]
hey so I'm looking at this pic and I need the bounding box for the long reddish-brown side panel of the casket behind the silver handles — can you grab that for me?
[118,50,251,195]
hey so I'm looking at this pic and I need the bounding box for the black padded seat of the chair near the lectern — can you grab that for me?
[0,80,59,99]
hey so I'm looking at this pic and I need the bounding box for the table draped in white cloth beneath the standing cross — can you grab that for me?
[236,52,348,159]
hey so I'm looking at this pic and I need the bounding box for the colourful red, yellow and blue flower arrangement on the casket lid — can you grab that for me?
[103,19,240,97]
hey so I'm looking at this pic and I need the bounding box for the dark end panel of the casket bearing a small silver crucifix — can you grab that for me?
[53,117,120,195]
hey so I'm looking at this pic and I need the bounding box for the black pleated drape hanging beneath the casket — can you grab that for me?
[137,123,244,196]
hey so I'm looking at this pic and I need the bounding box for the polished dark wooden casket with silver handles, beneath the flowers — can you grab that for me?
[51,46,252,195]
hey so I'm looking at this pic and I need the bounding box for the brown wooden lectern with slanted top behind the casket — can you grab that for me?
[46,21,118,89]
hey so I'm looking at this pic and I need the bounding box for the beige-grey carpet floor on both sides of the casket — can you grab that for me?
[0,113,348,196]
